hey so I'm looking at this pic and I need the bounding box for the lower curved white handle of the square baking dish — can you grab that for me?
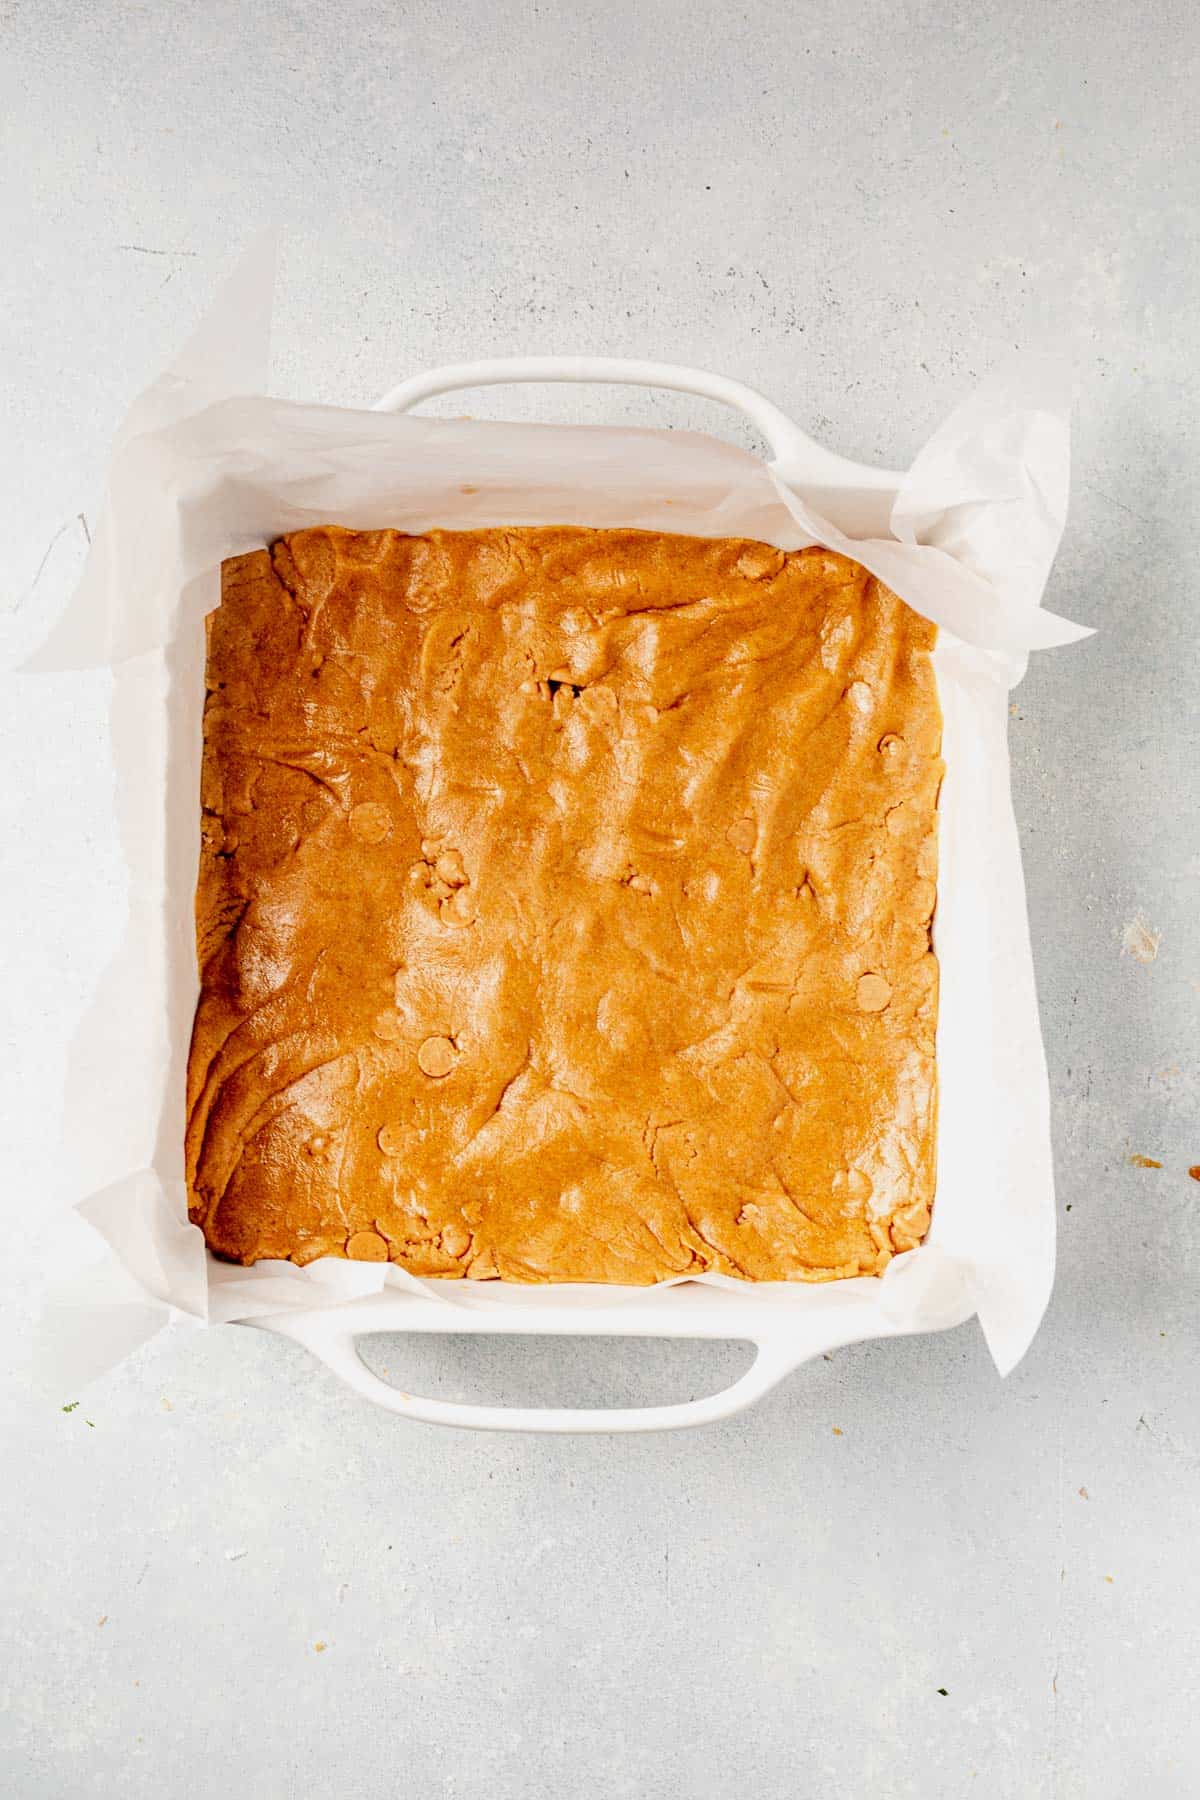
[262,1307,816,1431]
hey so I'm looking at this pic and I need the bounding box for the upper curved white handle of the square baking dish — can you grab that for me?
[372,356,903,490]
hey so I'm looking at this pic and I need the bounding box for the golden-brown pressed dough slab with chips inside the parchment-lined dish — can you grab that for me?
[187,527,941,1283]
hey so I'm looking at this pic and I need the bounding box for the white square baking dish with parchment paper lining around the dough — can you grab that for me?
[38,257,1083,1431]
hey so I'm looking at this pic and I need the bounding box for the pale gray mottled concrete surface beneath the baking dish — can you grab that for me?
[0,0,1200,1800]
